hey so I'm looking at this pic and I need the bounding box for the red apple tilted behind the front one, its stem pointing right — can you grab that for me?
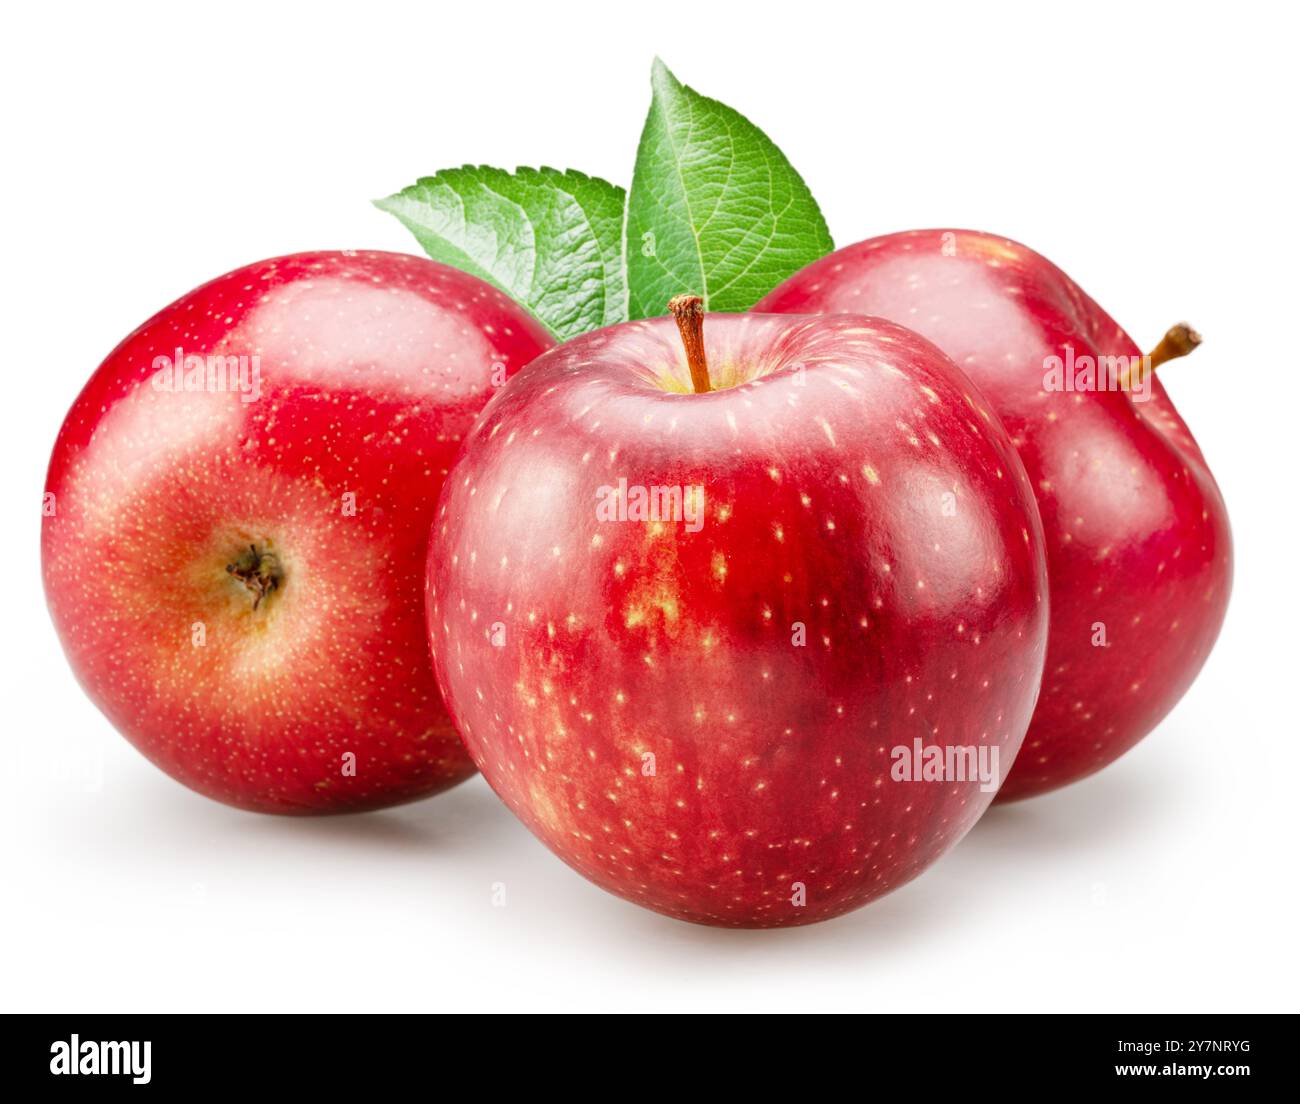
[754,230,1232,801]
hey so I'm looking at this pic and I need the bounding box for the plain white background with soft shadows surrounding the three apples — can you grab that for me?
[0,0,1300,1012]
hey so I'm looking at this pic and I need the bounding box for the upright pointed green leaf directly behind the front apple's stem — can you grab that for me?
[625,59,835,319]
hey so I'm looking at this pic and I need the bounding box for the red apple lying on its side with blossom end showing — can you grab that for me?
[42,252,553,813]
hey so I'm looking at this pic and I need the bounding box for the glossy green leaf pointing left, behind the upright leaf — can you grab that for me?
[374,165,628,339]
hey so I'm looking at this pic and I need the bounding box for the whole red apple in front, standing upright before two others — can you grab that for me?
[428,315,1047,927]
